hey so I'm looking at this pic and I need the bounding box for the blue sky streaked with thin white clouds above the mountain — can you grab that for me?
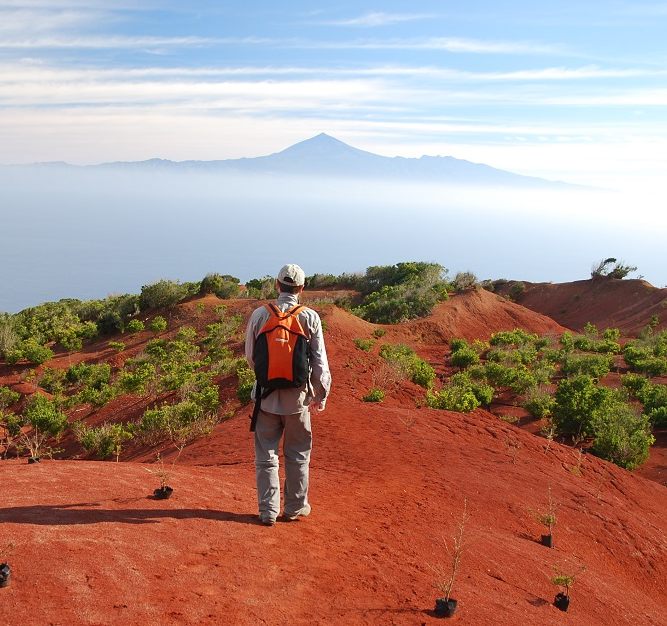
[0,0,667,192]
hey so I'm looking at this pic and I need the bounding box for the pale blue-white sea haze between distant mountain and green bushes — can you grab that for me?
[0,140,664,313]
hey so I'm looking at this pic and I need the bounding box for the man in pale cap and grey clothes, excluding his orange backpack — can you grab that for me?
[245,264,331,526]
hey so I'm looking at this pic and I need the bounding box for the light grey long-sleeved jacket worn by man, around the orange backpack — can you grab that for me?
[245,293,331,415]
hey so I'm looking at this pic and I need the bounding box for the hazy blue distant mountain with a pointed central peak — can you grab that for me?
[5,133,582,189]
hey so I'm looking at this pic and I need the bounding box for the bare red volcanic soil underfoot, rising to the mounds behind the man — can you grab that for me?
[0,284,667,626]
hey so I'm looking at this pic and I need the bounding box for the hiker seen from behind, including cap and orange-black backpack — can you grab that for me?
[245,264,331,526]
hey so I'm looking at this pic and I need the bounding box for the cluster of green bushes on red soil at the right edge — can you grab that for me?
[426,324,656,469]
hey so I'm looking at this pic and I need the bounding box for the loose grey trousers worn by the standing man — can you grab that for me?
[255,407,313,517]
